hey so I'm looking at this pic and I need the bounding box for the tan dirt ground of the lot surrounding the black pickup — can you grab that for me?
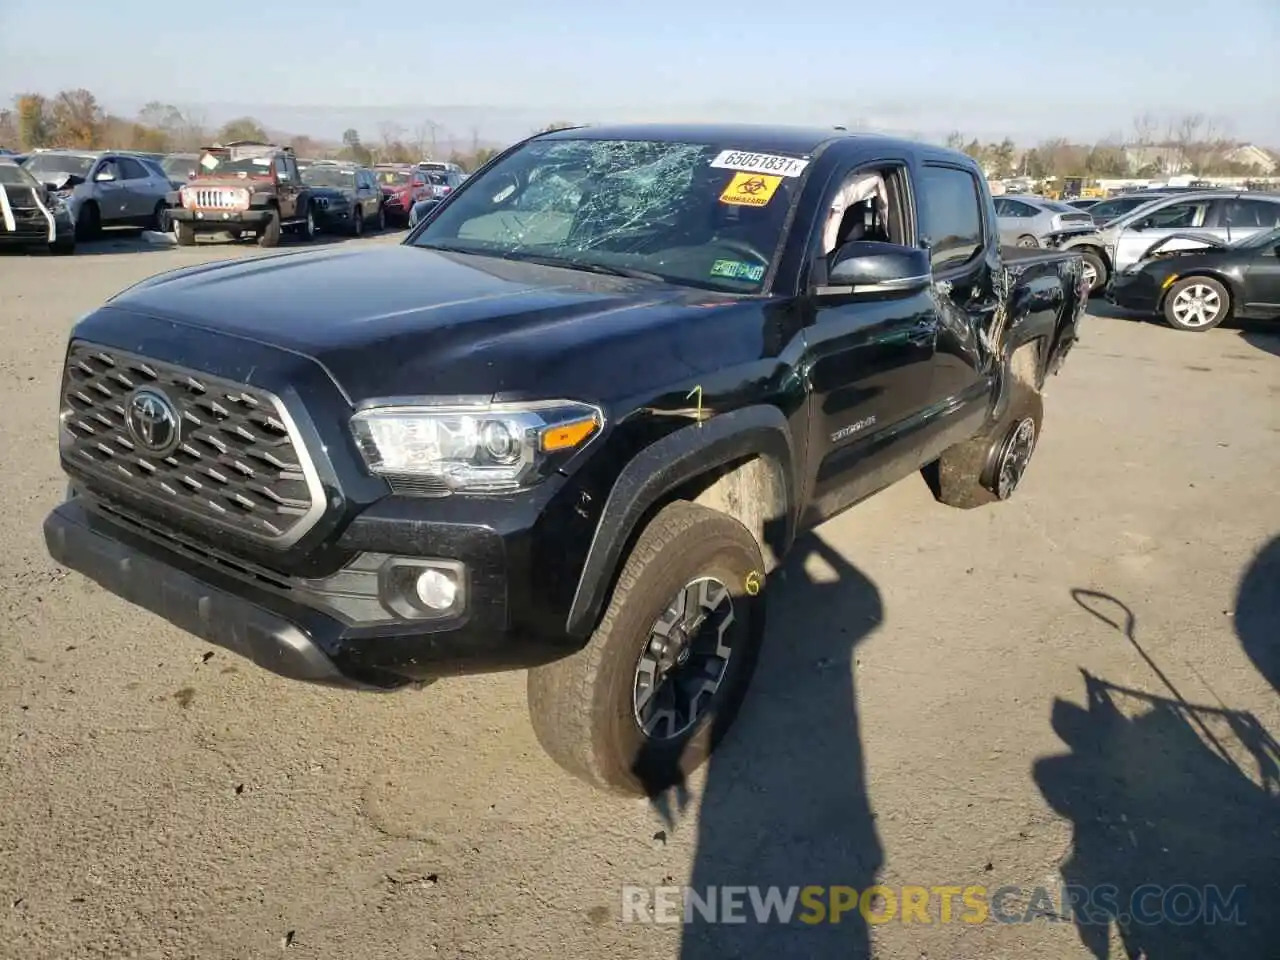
[0,236,1280,960]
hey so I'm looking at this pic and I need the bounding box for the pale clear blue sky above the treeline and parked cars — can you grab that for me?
[0,0,1280,147]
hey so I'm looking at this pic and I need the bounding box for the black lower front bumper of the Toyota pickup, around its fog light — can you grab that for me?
[45,497,570,690]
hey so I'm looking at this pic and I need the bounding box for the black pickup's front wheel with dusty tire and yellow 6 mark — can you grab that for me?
[529,500,764,796]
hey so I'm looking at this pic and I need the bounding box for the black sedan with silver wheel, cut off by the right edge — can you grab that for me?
[1107,228,1280,332]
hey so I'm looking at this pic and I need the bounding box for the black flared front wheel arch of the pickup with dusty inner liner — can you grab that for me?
[566,404,796,637]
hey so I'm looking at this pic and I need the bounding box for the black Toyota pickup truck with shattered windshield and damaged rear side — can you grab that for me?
[45,125,1085,792]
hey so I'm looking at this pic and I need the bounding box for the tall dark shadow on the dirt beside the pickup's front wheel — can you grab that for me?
[637,534,883,960]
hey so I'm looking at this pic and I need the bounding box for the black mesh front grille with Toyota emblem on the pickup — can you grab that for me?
[61,340,325,547]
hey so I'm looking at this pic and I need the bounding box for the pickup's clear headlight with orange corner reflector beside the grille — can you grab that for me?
[351,401,604,493]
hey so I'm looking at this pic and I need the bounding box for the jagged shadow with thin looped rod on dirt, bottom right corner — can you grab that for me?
[1034,590,1280,960]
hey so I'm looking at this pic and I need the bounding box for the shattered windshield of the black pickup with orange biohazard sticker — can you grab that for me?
[413,140,806,293]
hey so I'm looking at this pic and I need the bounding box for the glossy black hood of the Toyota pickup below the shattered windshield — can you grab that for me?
[99,244,762,403]
